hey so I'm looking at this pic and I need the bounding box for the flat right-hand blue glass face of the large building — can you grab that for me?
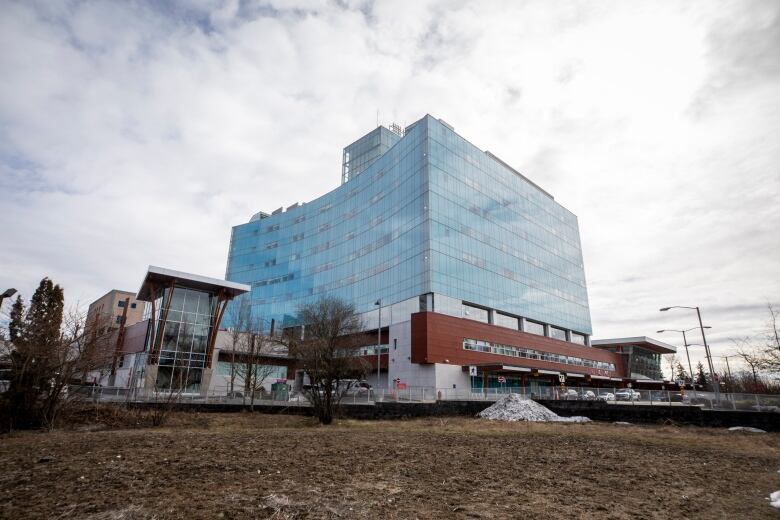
[427,117,591,334]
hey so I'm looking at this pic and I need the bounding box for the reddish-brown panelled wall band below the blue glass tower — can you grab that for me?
[412,312,622,377]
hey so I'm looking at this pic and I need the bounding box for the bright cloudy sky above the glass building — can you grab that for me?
[0,0,780,374]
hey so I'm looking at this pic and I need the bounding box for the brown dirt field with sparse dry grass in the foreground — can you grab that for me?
[0,414,780,520]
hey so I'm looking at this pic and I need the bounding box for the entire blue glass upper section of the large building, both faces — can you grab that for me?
[226,116,591,335]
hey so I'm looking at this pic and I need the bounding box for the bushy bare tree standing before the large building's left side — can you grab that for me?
[285,297,367,424]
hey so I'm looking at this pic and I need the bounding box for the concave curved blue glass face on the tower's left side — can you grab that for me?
[225,120,430,326]
